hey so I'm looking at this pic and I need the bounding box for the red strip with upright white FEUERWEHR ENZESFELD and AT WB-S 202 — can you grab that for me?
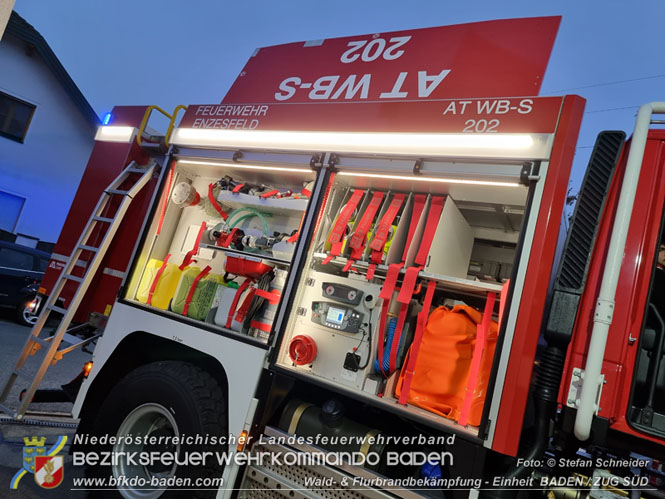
[180,97,563,133]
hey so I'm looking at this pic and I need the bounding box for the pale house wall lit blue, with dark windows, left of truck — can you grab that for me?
[0,12,99,246]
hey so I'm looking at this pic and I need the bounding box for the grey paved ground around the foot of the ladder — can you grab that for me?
[0,312,90,499]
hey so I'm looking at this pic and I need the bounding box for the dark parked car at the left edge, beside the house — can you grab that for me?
[0,241,50,326]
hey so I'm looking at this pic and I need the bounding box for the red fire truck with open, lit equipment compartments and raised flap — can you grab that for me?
[1,17,665,498]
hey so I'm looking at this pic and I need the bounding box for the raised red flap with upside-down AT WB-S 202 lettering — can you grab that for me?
[222,17,561,104]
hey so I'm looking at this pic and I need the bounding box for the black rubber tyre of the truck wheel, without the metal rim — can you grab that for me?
[86,361,227,498]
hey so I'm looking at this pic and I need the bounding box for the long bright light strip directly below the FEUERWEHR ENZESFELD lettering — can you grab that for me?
[171,128,551,159]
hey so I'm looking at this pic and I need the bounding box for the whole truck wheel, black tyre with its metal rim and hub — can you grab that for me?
[86,361,227,499]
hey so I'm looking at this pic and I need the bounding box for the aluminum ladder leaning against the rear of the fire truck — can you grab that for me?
[0,161,157,420]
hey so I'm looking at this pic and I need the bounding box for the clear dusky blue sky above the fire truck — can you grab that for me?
[14,0,665,191]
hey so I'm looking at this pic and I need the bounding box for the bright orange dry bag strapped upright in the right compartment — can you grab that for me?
[395,305,498,426]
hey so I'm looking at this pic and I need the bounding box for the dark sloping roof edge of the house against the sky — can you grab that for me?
[5,11,100,127]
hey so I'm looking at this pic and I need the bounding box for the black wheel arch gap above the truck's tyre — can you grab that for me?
[77,331,229,444]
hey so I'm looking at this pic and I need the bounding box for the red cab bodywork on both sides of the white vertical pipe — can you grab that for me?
[559,130,665,444]
